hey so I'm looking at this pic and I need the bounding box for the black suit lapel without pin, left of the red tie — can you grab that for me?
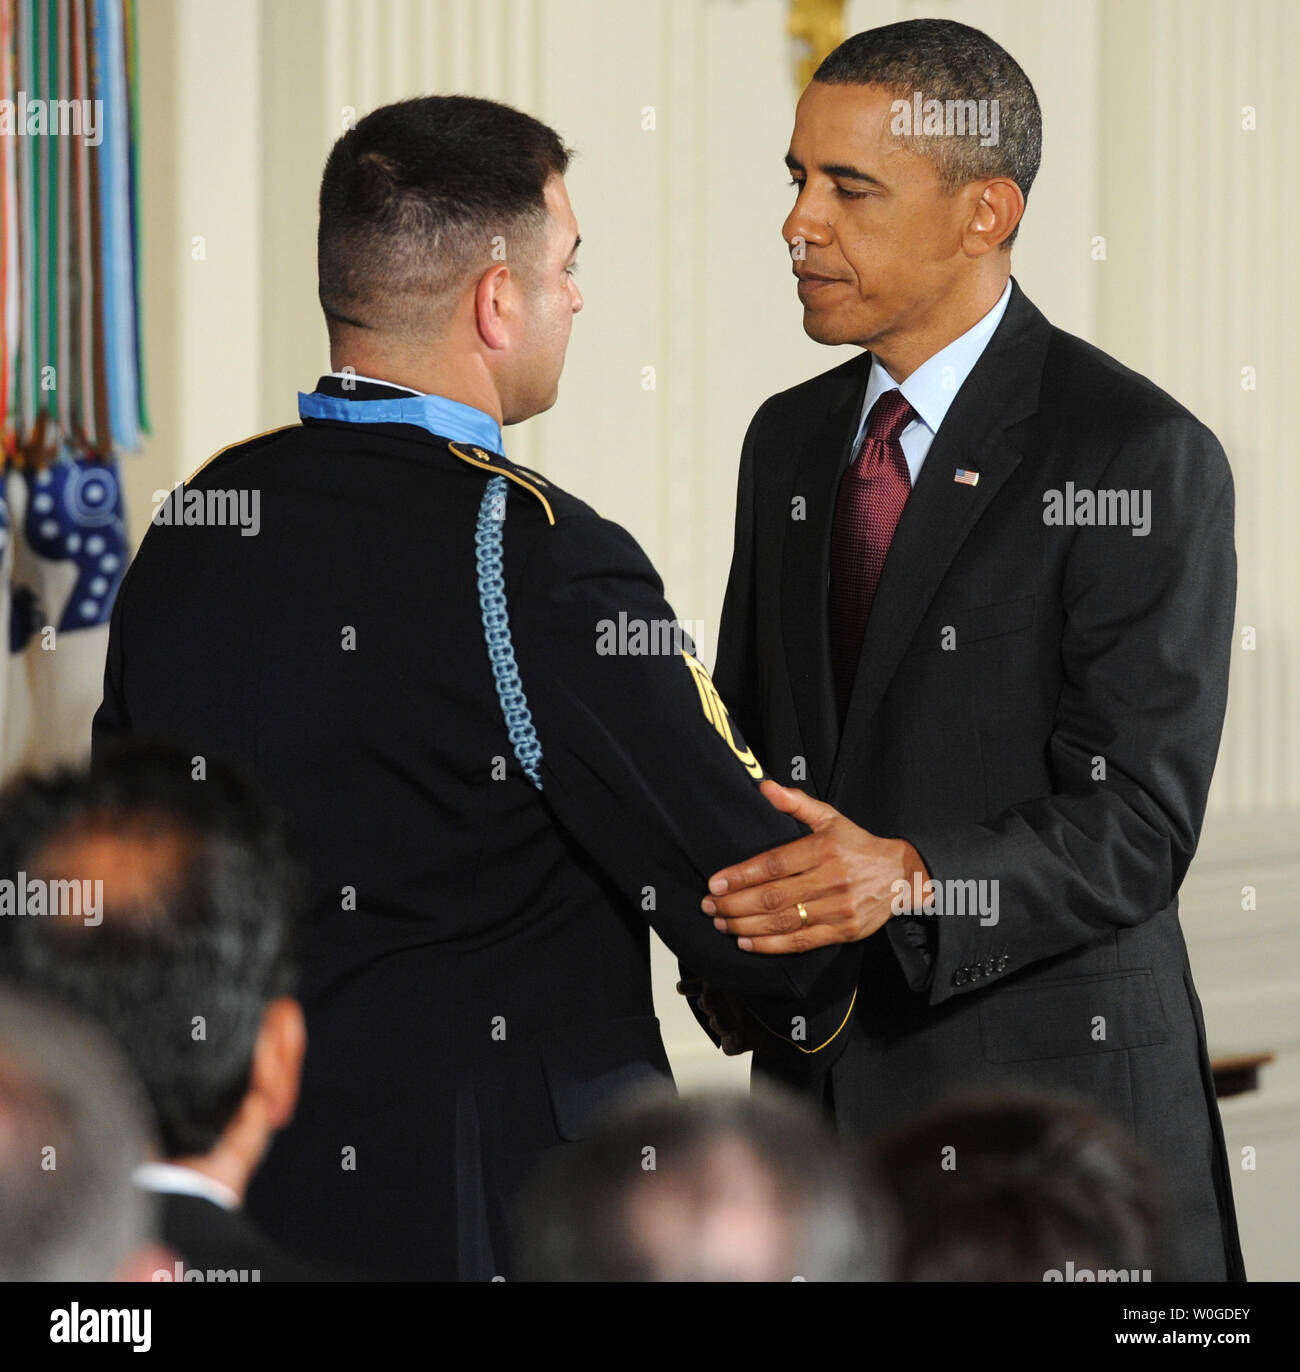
[780,353,871,794]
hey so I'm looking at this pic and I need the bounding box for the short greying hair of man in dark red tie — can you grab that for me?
[813,19,1042,247]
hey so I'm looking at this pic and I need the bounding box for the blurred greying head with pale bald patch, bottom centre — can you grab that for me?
[528,1093,886,1281]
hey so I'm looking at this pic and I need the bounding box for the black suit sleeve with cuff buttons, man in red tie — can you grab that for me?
[905,418,1236,1004]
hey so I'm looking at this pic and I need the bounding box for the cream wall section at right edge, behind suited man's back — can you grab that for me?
[1090,0,1300,1280]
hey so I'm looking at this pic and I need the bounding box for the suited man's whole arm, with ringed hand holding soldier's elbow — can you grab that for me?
[702,417,1236,1004]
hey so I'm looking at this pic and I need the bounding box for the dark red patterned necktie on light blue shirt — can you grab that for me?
[830,388,916,720]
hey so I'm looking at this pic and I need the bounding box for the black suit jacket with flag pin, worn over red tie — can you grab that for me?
[714,285,1242,1279]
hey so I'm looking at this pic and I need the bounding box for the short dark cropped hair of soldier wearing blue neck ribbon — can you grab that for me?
[317,95,572,338]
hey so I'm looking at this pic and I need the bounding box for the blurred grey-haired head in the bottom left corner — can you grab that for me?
[0,986,169,1281]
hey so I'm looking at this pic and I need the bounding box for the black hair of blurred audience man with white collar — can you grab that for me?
[0,745,300,1158]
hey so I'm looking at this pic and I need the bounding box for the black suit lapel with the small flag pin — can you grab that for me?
[823,285,1050,796]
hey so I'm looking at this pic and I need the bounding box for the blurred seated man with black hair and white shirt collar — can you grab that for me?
[0,748,326,1281]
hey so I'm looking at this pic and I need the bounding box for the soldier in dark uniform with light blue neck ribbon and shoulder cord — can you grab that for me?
[95,96,858,1279]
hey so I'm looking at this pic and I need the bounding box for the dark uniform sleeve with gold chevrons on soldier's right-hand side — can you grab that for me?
[506,516,858,1062]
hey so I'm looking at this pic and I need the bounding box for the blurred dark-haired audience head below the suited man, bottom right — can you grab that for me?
[869,1093,1155,1281]
